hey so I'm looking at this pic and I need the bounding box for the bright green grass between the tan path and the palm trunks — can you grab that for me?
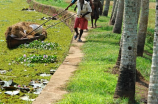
[33,0,155,104]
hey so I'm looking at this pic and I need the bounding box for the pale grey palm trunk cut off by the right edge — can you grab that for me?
[148,0,158,104]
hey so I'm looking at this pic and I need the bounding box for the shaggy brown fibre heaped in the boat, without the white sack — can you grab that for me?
[5,22,47,39]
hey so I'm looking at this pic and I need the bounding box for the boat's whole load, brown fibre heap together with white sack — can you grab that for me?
[5,22,47,39]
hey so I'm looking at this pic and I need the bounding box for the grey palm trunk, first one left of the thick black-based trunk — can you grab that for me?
[113,0,124,34]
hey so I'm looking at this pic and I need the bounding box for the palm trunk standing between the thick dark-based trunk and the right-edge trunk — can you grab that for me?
[137,0,149,56]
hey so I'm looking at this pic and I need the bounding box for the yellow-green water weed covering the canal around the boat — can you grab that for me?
[0,0,72,104]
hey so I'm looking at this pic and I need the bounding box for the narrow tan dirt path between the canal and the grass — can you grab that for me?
[32,31,88,104]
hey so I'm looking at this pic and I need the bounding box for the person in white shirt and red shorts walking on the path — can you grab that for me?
[66,0,92,42]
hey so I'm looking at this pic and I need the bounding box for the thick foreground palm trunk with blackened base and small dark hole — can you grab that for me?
[114,0,137,104]
